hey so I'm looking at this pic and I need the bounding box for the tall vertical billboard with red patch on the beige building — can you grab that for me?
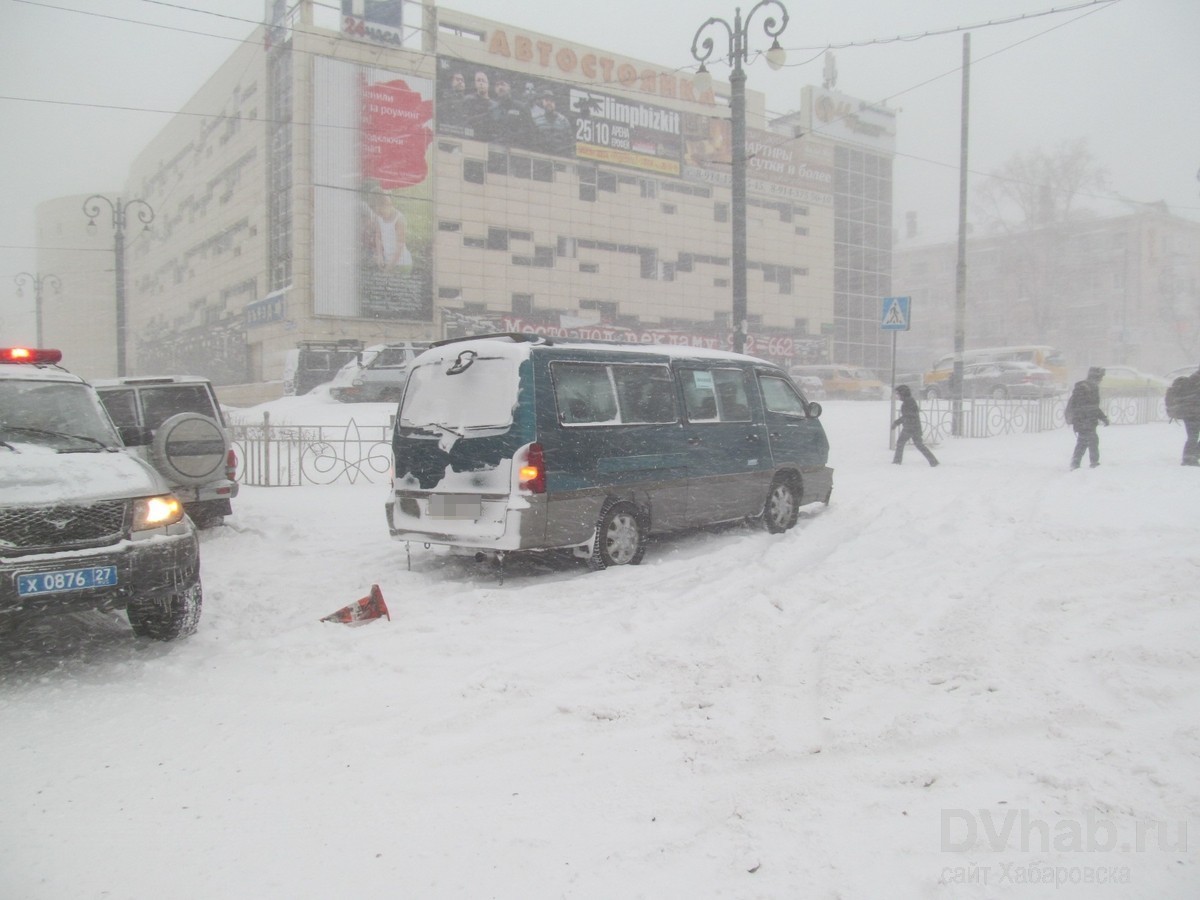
[312,56,433,322]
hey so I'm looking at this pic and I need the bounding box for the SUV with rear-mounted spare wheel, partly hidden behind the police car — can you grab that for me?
[92,376,238,528]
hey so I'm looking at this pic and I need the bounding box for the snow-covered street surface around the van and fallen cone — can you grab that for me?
[0,398,1200,900]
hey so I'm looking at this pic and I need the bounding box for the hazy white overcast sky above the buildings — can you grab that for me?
[0,0,1200,335]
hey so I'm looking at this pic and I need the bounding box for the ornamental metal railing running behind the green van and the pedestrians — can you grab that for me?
[229,397,1166,487]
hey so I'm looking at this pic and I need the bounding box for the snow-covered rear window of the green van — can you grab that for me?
[398,353,521,433]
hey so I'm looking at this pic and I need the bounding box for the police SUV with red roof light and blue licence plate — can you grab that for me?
[0,348,203,641]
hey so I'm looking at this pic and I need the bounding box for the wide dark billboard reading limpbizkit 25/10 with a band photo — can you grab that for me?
[437,56,683,176]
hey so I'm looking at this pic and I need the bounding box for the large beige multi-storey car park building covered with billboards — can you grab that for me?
[32,0,895,385]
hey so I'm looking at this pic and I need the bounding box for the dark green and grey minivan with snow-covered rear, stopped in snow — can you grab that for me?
[386,334,833,569]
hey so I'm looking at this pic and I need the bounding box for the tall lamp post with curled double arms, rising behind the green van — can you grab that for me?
[691,0,787,353]
